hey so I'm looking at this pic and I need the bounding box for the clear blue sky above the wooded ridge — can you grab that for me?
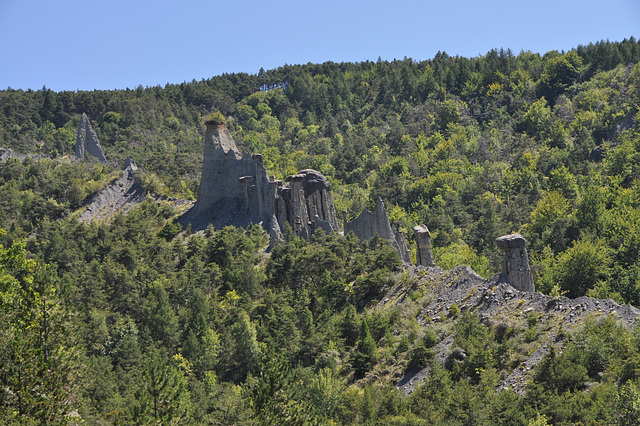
[0,0,640,91]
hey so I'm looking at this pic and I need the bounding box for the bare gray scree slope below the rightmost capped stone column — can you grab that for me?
[378,266,640,393]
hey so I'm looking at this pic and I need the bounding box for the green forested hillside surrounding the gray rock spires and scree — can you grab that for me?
[0,37,640,425]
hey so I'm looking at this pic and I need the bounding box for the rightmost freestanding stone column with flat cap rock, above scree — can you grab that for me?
[496,234,536,292]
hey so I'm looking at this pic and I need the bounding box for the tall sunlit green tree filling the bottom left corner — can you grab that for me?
[0,236,80,424]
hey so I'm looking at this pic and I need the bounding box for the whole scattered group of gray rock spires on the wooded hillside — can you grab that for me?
[76,113,535,292]
